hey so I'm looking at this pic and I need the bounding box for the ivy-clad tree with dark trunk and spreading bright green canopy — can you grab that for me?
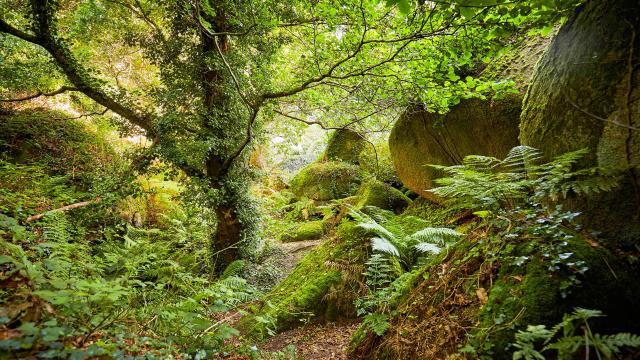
[0,0,575,264]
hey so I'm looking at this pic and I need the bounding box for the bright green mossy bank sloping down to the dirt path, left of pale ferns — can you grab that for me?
[239,222,368,339]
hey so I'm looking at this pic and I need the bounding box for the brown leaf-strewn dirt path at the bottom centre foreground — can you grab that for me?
[260,322,358,360]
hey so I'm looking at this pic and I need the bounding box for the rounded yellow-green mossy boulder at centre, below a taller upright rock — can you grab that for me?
[289,161,363,201]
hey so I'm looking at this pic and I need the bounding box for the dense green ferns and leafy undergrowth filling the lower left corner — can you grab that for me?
[0,163,259,358]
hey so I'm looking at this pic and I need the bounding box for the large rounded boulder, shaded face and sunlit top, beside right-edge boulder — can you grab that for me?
[389,38,549,201]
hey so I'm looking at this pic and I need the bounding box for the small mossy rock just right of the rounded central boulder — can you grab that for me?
[356,179,411,213]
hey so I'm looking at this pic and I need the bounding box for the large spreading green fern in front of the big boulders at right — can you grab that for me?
[429,146,622,210]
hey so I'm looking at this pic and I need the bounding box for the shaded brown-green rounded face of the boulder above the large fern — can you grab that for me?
[389,95,521,200]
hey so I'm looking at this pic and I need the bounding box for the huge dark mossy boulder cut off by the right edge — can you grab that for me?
[520,0,640,243]
